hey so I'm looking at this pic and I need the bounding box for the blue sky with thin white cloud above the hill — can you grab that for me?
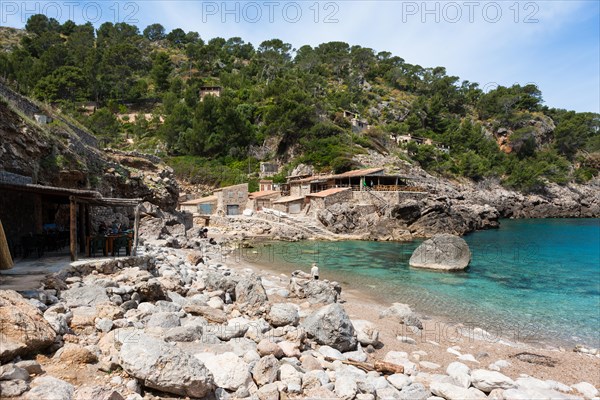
[0,0,600,112]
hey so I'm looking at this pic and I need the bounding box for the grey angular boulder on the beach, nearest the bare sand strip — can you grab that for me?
[301,303,357,352]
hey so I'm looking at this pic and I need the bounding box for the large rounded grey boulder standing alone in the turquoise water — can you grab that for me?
[408,233,471,271]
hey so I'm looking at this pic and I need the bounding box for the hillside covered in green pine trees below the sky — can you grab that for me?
[0,15,600,195]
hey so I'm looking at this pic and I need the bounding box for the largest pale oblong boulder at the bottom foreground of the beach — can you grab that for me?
[119,332,215,397]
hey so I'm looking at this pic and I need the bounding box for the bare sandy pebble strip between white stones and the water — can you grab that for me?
[224,244,600,387]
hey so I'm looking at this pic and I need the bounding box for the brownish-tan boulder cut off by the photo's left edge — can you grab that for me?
[0,290,56,362]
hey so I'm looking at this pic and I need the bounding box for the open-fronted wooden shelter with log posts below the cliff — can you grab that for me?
[0,180,142,261]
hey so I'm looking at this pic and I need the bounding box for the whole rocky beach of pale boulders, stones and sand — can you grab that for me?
[0,220,600,400]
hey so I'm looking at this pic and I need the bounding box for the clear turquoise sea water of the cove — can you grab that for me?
[244,219,600,347]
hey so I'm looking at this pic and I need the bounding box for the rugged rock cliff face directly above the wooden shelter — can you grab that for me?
[0,88,179,210]
